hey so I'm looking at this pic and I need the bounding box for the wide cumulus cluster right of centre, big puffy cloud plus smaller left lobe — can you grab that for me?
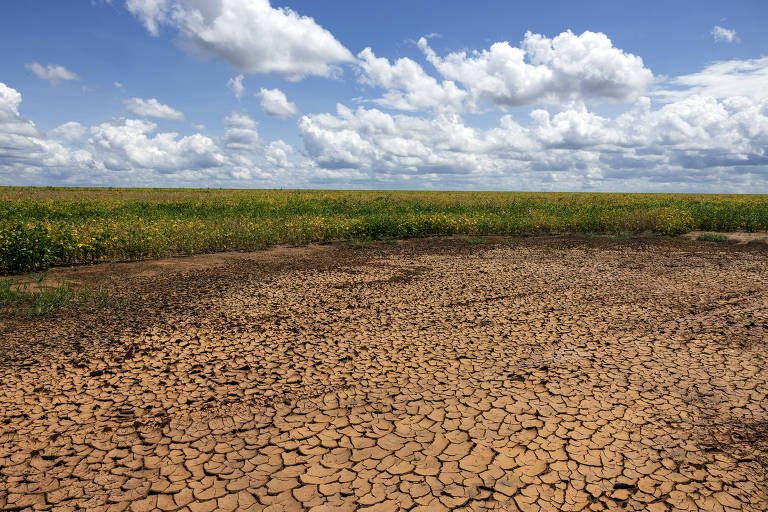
[357,31,653,112]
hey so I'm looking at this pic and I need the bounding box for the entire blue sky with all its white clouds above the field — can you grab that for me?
[0,0,768,193]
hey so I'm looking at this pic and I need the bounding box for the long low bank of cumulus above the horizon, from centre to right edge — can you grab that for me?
[299,91,768,191]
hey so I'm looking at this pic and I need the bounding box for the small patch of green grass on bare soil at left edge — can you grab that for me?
[0,273,126,316]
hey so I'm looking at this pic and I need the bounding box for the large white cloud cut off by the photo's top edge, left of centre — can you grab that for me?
[126,0,354,80]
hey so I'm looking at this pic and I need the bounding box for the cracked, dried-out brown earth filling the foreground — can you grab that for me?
[0,237,768,512]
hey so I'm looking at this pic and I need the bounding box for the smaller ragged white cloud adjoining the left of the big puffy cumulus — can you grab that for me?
[357,48,467,111]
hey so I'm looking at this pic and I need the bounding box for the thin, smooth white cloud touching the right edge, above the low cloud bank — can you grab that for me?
[654,57,768,101]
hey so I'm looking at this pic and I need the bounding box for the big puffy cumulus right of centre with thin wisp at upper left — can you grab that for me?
[418,31,653,106]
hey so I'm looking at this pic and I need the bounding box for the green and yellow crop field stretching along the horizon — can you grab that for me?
[0,187,768,274]
